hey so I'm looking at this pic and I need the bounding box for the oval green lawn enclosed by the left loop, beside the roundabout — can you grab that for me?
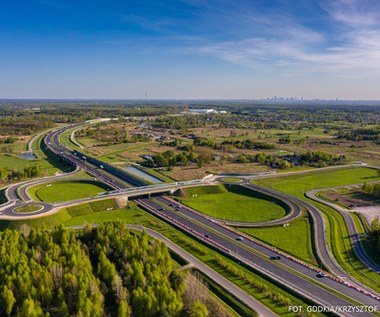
[29,180,110,202]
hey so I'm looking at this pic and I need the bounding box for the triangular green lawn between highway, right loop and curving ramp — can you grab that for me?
[239,217,316,264]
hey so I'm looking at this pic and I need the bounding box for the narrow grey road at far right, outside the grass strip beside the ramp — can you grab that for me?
[305,184,380,273]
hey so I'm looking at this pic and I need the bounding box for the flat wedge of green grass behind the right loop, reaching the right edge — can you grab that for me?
[252,167,380,198]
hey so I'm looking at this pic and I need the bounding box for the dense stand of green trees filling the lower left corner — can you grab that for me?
[0,222,208,317]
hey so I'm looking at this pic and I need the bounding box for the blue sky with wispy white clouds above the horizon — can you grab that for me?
[0,0,380,99]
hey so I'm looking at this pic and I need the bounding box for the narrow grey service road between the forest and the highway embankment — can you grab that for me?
[68,224,278,317]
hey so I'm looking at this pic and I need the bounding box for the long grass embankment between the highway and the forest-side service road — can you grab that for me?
[0,199,322,317]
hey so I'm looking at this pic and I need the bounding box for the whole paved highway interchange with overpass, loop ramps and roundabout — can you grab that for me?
[0,120,380,316]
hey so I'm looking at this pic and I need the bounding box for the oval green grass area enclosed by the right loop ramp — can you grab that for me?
[179,185,286,222]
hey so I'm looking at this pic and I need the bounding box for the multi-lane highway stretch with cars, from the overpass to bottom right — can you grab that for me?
[137,197,380,316]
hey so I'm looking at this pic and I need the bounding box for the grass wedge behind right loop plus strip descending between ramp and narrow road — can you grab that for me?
[254,168,380,291]
